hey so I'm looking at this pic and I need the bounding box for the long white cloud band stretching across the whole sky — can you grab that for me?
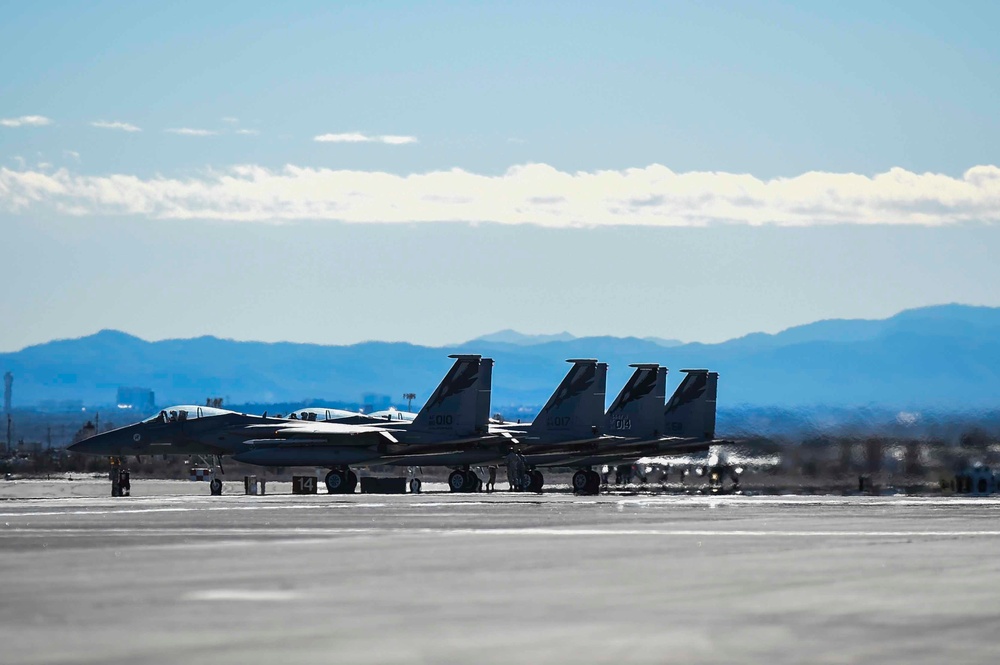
[0,164,1000,227]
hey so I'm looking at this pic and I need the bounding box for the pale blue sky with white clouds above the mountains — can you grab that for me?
[0,2,1000,351]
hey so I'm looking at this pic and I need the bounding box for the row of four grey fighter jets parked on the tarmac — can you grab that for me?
[70,355,718,494]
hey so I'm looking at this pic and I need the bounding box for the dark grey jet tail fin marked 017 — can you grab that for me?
[527,359,608,441]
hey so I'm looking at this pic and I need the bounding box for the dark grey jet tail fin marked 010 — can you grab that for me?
[410,355,493,438]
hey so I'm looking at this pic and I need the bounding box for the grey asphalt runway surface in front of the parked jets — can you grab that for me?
[0,480,1000,664]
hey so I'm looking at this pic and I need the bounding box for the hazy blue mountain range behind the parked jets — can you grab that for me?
[0,305,1000,411]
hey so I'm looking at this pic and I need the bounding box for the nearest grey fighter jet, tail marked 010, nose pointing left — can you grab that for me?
[69,355,495,493]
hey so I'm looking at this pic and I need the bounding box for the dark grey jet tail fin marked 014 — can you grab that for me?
[605,363,667,439]
